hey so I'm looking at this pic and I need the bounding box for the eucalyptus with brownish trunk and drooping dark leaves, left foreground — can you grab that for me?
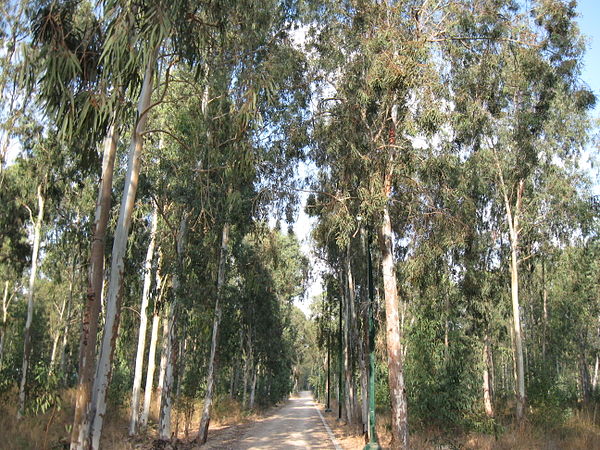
[28,1,122,442]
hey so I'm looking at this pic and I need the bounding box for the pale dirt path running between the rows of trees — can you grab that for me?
[203,391,335,450]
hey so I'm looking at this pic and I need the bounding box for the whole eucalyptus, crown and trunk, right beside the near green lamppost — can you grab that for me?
[308,2,462,447]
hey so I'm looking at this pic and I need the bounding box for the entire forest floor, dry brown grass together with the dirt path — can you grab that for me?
[0,391,600,450]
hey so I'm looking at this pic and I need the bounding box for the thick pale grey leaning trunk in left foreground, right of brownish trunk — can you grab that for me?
[90,50,158,449]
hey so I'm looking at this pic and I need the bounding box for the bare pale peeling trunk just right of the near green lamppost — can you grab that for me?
[378,204,408,448]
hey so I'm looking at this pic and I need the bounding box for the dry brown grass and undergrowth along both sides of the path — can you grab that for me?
[0,389,600,450]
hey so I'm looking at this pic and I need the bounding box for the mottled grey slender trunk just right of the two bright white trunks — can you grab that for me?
[158,213,187,440]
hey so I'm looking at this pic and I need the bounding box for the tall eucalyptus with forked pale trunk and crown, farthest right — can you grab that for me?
[450,0,594,420]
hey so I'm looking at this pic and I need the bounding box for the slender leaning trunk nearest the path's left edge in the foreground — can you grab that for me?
[198,223,229,445]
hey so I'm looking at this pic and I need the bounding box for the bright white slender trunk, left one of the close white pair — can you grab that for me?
[129,203,158,436]
